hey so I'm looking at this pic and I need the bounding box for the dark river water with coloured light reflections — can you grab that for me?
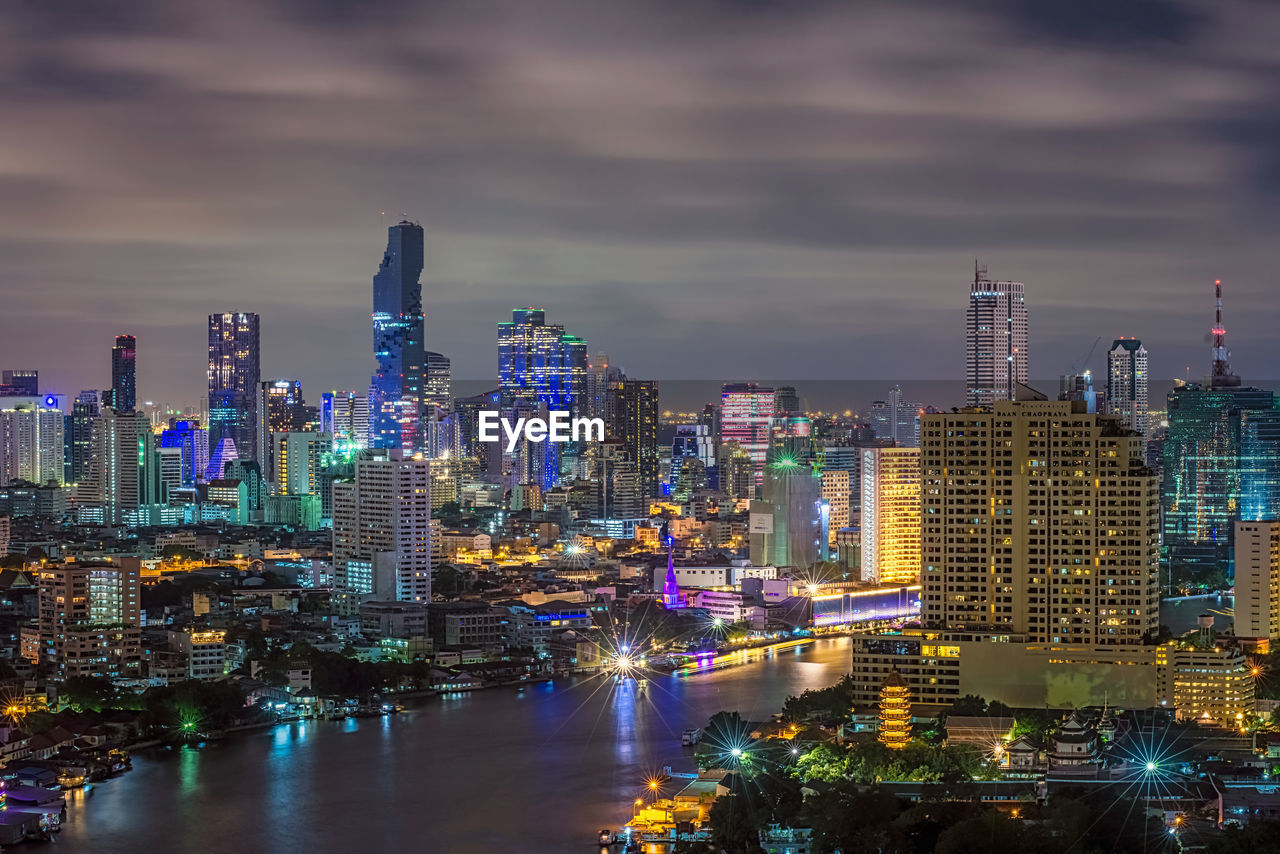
[56,638,850,854]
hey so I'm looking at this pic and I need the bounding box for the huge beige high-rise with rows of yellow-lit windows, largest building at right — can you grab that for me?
[921,401,1160,647]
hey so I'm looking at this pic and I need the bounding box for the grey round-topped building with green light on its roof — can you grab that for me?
[749,457,829,570]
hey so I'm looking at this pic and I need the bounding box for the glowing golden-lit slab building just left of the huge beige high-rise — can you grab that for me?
[861,448,920,584]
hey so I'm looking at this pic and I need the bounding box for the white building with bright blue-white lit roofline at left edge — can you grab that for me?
[0,396,67,485]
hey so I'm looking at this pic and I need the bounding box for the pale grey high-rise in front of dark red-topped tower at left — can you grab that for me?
[81,407,168,525]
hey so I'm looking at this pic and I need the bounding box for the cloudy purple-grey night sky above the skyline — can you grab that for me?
[0,0,1280,402]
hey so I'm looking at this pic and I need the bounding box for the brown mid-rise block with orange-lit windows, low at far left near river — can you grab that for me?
[31,558,142,680]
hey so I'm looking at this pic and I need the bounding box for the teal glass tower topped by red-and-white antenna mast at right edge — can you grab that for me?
[1161,282,1280,575]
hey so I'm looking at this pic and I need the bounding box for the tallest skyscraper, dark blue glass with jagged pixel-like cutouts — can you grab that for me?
[369,220,426,453]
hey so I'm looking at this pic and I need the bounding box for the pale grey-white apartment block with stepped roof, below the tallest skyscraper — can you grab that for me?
[333,451,431,613]
